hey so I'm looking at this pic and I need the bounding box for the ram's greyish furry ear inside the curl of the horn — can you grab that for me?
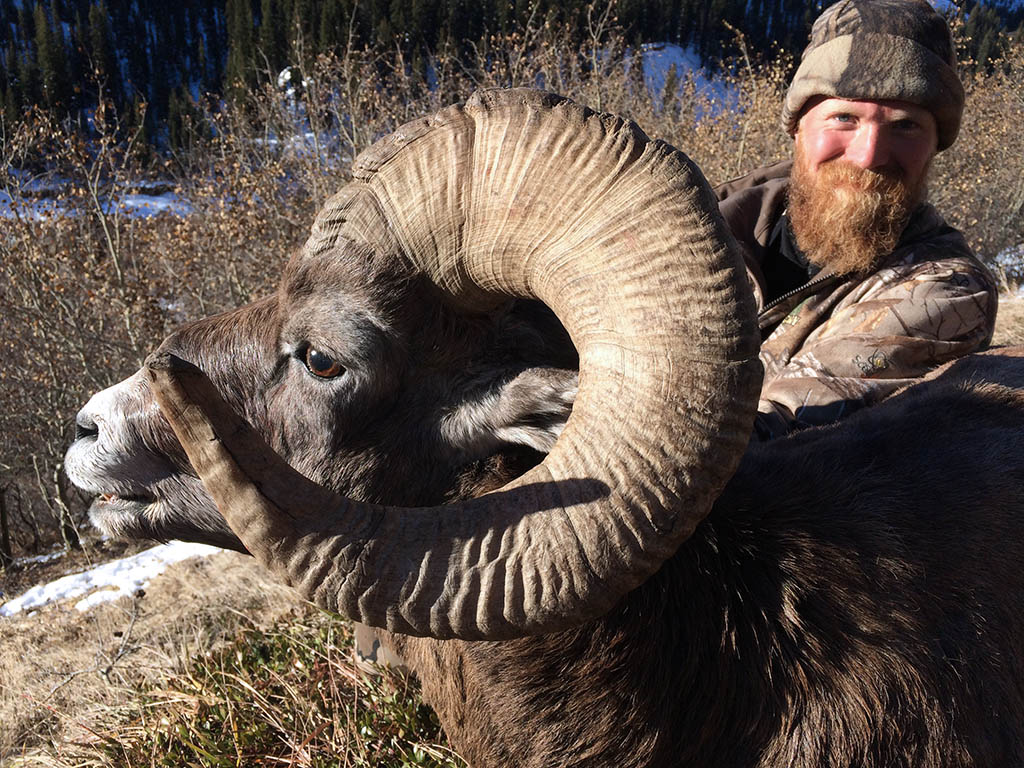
[441,368,578,460]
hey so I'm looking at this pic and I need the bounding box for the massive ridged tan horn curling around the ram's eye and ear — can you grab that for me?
[150,90,760,639]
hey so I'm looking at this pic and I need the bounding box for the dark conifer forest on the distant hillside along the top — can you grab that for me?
[0,0,1024,144]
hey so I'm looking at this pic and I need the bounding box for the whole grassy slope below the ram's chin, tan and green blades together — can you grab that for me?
[0,552,462,767]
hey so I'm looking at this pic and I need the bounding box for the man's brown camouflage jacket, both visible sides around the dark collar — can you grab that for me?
[716,157,997,439]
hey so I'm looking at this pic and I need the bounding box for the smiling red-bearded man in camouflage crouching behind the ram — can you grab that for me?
[717,0,996,439]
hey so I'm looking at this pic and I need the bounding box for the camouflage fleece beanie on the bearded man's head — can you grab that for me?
[782,0,964,151]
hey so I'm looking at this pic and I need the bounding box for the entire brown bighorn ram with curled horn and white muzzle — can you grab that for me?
[67,91,1024,768]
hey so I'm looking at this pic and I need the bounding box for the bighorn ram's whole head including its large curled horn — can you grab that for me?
[69,90,761,640]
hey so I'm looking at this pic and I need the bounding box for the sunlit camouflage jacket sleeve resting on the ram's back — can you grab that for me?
[757,257,996,439]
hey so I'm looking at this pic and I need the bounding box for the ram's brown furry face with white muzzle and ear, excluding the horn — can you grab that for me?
[66,254,575,550]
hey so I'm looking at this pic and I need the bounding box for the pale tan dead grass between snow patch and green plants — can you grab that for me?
[0,552,303,765]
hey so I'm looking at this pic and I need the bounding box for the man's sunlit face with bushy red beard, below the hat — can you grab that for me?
[790,97,938,273]
